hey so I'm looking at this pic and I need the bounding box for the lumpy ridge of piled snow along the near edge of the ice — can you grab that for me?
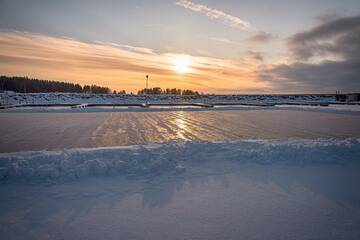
[0,139,360,183]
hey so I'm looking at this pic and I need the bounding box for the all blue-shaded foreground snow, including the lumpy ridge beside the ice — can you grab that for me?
[0,139,360,240]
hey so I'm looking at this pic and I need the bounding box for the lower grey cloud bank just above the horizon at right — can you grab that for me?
[261,60,360,93]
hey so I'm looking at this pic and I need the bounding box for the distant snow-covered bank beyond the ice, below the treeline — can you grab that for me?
[0,92,336,105]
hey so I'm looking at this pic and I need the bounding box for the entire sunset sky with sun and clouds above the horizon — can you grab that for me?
[0,0,360,94]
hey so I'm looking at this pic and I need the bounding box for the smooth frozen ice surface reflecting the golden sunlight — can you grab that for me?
[0,106,360,152]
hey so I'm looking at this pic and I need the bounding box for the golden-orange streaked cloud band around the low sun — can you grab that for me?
[0,32,271,93]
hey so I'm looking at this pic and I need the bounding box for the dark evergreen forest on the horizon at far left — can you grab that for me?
[0,76,111,94]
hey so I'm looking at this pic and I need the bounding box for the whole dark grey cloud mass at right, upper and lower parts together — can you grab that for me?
[260,16,360,92]
